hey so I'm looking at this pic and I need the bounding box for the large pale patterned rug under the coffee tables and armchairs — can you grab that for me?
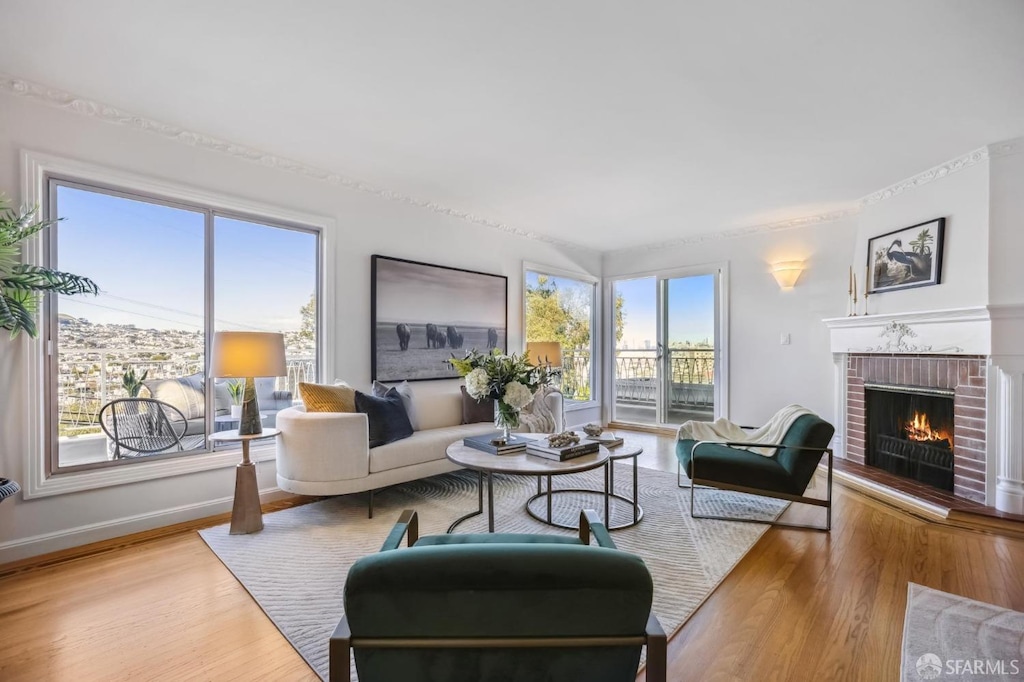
[200,465,786,680]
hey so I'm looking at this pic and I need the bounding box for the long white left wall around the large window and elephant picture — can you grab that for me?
[0,89,600,563]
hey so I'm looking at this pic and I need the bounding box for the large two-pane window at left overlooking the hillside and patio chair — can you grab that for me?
[47,178,321,473]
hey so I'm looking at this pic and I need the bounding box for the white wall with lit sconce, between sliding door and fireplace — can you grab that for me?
[604,218,856,424]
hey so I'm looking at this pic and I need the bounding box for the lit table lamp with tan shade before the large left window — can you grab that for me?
[210,332,288,435]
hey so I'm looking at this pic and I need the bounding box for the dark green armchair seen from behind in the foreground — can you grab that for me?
[330,510,666,682]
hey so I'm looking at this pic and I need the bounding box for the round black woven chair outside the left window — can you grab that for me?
[99,397,188,459]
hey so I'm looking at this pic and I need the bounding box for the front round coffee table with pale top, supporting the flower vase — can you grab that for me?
[445,434,610,532]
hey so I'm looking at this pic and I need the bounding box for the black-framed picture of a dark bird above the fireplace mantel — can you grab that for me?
[867,218,946,294]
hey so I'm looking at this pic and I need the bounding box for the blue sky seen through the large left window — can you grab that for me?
[56,186,316,331]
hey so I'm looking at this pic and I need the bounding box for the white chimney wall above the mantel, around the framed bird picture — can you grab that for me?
[852,162,988,313]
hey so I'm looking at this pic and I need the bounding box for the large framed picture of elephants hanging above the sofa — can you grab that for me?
[370,255,508,381]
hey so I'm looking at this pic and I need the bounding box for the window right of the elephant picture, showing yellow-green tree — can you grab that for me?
[523,269,597,406]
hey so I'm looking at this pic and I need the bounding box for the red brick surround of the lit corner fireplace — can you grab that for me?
[845,353,988,504]
